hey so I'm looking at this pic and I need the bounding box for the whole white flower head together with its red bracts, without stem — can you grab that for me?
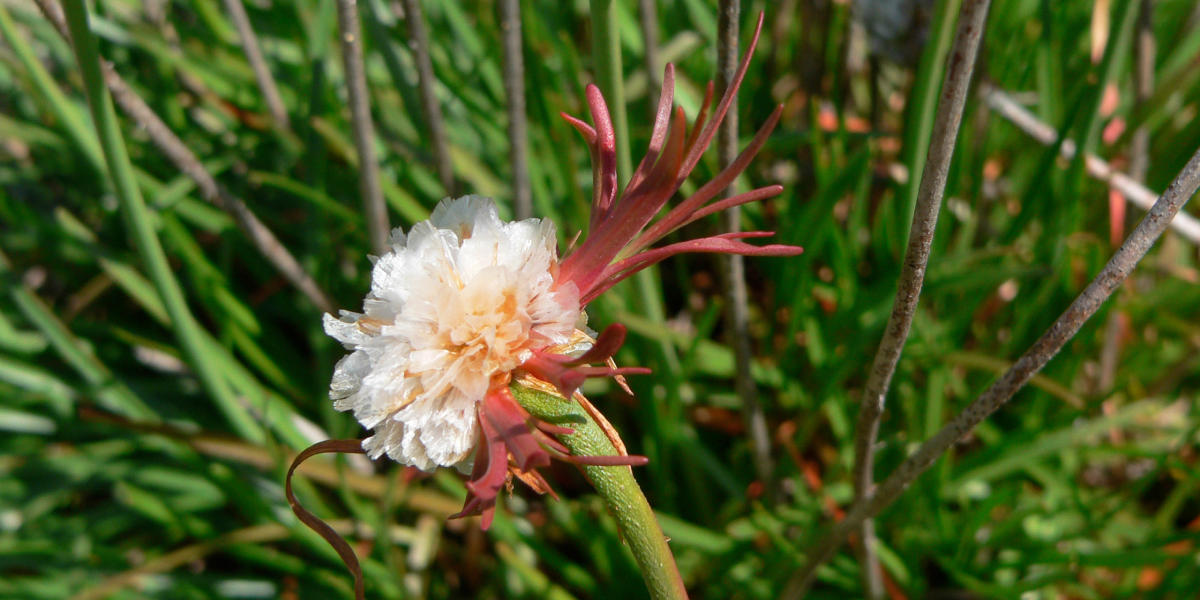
[325,16,802,529]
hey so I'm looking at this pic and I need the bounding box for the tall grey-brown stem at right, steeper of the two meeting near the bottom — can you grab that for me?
[853,0,991,599]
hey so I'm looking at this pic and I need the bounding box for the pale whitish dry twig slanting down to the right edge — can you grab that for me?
[979,84,1200,244]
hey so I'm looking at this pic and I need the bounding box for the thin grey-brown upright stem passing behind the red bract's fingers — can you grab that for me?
[715,0,773,500]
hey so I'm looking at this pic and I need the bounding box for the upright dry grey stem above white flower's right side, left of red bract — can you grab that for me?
[500,0,533,218]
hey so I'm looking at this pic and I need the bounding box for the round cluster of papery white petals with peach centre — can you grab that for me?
[324,196,581,470]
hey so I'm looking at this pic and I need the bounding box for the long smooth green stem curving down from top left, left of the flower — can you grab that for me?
[64,0,265,443]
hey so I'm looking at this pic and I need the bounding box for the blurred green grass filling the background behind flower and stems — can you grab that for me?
[0,0,1200,599]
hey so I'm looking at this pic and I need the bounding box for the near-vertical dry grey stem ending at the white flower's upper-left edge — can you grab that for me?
[337,0,391,254]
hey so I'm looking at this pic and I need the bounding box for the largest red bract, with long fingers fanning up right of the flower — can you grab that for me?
[558,14,803,305]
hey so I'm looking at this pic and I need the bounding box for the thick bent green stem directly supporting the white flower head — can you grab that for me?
[512,385,688,600]
